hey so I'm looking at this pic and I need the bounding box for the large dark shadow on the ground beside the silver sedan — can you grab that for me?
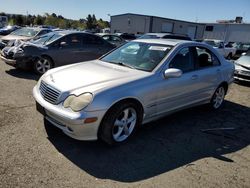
[45,101,250,182]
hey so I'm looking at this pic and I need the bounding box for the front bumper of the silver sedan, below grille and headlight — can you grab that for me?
[33,86,106,140]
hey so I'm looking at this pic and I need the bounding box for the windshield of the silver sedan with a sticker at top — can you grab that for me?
[101,42,173,71]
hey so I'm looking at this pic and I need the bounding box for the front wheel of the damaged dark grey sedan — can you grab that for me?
[34,56,53,75]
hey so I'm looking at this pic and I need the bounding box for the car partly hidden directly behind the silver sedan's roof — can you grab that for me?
[139,33,192,41]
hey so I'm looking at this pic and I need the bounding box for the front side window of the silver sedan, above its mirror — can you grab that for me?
[169,48,194,73]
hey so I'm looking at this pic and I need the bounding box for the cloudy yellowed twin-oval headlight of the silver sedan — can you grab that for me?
[63,93,93,112]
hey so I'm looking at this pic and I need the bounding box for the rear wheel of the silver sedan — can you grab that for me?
[210,85,226,110]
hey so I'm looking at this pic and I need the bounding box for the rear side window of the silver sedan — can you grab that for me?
[195,47,220,69]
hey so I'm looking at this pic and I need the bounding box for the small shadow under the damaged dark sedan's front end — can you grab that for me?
[5,69,40,81]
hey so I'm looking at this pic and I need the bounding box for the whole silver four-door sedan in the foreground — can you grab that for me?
[33,39,234,144]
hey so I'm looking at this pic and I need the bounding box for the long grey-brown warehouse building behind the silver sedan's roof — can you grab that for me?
[111,13,205,39]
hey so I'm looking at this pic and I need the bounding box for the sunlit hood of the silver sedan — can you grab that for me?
[42,60,151,95]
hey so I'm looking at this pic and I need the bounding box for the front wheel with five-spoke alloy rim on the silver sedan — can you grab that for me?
[100,102,142,145]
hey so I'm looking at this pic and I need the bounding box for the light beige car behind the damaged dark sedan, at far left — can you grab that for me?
[0,27,51,49]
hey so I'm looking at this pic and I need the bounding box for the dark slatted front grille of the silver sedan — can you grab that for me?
[39,81,60,104]
